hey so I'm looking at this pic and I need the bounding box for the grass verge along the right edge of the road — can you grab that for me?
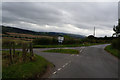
[105,45,120,59]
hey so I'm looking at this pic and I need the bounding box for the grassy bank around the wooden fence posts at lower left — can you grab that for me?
[2,51,53,79]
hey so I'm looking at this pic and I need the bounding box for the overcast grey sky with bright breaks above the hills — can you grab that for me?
[2,2,118,37]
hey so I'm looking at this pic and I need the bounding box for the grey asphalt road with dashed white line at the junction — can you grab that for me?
[34,45,118,78]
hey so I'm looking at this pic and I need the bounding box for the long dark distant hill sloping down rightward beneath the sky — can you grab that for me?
[0,25,85,38]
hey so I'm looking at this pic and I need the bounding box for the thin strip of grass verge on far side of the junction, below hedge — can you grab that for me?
[33,43,102,48]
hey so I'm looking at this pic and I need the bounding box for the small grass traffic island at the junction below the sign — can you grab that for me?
[43,49,79,54]
